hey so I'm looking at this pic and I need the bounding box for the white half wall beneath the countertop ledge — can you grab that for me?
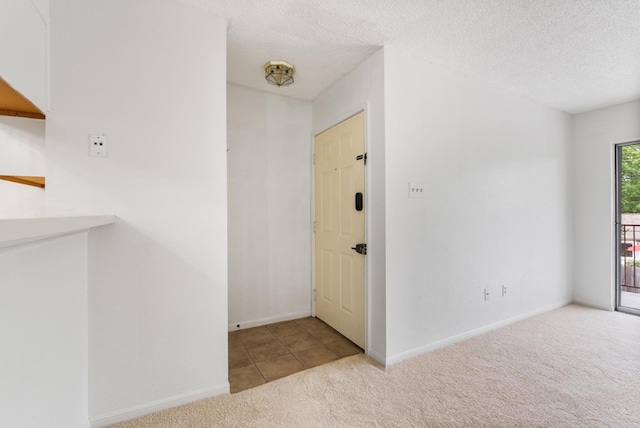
[0,233,87,428]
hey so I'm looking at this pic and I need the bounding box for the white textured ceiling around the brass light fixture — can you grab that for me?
[179,0,640,113]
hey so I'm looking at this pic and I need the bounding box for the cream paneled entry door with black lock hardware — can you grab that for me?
[314,113,366,348]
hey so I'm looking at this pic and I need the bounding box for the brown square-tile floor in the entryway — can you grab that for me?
[229,317,362,393]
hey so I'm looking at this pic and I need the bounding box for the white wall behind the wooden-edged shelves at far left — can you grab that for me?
[0,116,45,218]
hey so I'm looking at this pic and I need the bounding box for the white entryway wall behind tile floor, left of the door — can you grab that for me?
[227,83,311,329]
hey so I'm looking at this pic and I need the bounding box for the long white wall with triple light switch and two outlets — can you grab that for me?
[385,48,572,363]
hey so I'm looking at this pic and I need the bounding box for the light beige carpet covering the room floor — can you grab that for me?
[118,305,640,428]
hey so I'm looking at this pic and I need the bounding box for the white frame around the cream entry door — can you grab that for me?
[309,102,372,355]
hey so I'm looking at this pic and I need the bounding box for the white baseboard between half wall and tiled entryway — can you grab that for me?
[89,382,229,428]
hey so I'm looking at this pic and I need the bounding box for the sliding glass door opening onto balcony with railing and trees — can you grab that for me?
[615,141,640,315]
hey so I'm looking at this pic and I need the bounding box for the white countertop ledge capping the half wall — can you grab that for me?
[0,215,116,248]
